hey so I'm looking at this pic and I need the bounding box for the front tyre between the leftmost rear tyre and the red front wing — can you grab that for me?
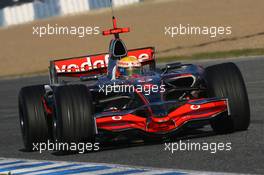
[53,85,95,143]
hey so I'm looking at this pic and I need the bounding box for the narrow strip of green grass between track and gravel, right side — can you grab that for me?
[157,48,264,63]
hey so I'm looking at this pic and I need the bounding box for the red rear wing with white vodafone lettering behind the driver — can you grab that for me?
[50,47,155,81]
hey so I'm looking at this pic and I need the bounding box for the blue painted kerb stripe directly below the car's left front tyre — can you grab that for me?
[35,166,112,175]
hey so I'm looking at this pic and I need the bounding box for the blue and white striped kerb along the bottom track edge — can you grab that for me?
[0,158,227,175]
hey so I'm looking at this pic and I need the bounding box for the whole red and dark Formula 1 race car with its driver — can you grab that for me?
[19,17,250,151]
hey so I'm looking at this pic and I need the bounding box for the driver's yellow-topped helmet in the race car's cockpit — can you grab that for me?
[117,56,141,76]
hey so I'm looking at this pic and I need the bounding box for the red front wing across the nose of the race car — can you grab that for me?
[96,99,228,133]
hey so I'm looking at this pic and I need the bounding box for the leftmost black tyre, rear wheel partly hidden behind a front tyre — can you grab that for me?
[18,85,50,151]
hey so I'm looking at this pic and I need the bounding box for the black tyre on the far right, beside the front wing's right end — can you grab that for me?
[205,63,250,133]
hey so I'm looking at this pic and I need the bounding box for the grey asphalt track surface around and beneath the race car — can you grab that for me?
[0,57,264,174]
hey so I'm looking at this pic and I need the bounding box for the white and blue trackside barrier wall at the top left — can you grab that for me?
[0,0,143,26]
